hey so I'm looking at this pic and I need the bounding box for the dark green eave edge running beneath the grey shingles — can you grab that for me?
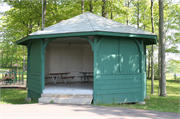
[16,31,157,45]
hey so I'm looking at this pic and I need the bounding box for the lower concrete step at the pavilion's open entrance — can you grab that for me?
[39,97,92,104]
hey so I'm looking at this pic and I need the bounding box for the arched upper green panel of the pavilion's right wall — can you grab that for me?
[98,37,140,74]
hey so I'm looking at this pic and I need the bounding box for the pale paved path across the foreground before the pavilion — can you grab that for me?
[0,103,180,119]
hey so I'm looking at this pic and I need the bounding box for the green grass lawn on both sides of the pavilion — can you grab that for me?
[0,68,180,113]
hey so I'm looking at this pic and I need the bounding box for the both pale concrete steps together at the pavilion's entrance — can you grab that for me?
[38,94,93,104]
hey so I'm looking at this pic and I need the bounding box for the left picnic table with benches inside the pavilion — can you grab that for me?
[45,72,75,85]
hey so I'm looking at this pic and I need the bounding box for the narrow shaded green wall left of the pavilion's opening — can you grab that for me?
[27,40,44,99]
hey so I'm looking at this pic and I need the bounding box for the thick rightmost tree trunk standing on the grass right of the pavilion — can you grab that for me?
[159,0,167,97]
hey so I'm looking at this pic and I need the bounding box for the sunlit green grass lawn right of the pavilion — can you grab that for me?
[96,80,180,113]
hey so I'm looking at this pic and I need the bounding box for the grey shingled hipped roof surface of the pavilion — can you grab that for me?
[30,12,155,35]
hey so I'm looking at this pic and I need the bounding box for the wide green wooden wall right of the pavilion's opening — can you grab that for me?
[94,37,146,104]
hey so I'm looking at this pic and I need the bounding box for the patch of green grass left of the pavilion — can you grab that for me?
[0,88,38,104]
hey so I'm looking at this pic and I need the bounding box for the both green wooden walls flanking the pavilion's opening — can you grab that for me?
[25,36,146,104]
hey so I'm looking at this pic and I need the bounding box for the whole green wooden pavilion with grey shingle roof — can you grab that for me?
[16,12,157,104]
